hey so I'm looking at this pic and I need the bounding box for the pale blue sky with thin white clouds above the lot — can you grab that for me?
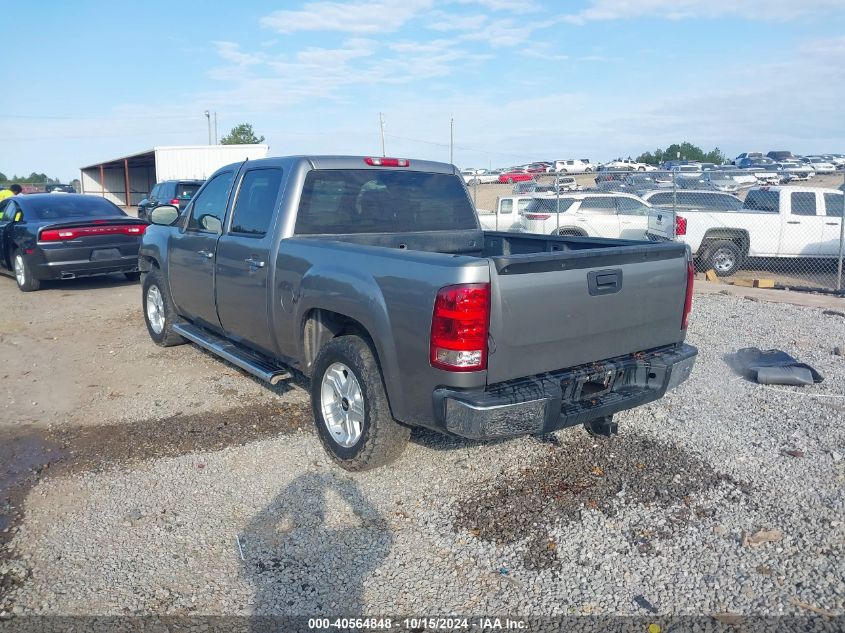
[0,0,845,180]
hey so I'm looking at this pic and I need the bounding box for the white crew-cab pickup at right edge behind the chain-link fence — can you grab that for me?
[647,187,845,277]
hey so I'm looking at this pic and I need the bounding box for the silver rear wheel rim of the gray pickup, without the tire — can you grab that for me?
[320,363,364,448]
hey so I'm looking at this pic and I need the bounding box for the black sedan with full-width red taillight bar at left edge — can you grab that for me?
[0,193,147,292]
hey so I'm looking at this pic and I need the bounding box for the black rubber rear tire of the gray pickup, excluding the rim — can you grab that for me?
[311,336,411,471]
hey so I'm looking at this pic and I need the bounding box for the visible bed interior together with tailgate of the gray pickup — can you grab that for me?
[300,230,688,384]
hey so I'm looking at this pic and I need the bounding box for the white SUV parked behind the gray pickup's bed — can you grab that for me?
[521,191,652,240]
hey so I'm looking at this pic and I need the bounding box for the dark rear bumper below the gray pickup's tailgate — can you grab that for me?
[434,344,698,439]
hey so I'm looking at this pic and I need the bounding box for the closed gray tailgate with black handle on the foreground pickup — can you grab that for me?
[487,242,688,383]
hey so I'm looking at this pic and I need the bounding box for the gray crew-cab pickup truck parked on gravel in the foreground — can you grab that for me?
[140,156,696,470]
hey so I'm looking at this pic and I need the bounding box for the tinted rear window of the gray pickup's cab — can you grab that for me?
[296,169,478,235]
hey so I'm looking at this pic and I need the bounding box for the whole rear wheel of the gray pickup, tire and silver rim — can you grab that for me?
[311,336,411,471]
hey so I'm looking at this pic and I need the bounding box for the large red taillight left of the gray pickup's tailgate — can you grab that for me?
[430,284,490,371]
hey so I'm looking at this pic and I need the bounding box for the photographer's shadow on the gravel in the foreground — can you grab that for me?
[239,473,393,616]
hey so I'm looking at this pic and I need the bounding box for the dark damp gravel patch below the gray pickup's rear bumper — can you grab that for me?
[454,435,747,569]
